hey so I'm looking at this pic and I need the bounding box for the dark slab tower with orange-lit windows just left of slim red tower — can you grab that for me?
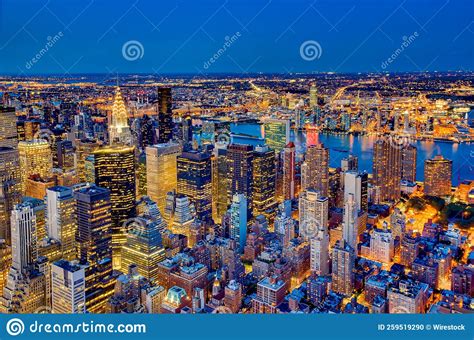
[253,146,276,219]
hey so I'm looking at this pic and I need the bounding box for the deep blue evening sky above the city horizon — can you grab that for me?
[0,0,474,74]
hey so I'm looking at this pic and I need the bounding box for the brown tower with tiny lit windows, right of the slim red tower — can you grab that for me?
[301,143,329,196]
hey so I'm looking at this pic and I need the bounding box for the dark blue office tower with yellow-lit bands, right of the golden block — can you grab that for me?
[177,150,212,221]
